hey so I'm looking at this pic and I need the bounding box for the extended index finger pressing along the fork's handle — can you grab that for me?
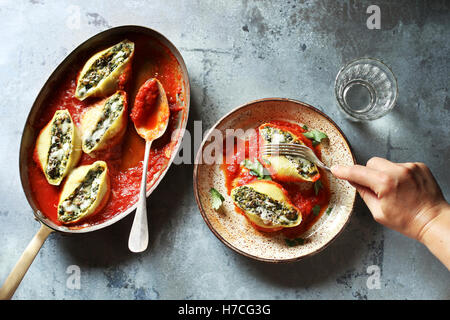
[331,165,386,195]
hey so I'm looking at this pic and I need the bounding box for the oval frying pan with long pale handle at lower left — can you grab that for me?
[0,25,190,299]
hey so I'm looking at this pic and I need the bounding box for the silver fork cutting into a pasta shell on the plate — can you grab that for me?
[262,143,331,172]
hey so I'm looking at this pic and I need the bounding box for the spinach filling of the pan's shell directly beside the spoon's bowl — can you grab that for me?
[84,93,123,150]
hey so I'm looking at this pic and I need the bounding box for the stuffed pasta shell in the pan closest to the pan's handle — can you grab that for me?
[57,161,110,224]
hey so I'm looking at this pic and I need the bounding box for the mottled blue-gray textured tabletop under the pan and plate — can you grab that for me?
[0,0,450,299]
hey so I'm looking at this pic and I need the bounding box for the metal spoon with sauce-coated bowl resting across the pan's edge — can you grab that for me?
[128,78,170,252]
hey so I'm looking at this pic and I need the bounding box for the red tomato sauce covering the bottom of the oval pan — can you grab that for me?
[28,35,184,228]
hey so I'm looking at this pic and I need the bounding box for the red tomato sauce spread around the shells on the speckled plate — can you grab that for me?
[221,121,330,238]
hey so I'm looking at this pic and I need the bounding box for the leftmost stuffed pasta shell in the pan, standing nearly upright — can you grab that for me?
[35,110,81,185]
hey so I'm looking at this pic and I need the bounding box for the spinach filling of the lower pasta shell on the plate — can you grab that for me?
[233,186,298,225]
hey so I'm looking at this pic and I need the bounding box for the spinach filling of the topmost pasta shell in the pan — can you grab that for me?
[79,42,133,93]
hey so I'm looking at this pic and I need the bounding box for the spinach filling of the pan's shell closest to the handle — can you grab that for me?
[58,166,105,222]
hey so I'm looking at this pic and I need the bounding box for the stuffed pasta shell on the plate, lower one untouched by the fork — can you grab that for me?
[231,180,302,229]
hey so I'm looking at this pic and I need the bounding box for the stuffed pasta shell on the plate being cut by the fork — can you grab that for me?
[258,123,320,182]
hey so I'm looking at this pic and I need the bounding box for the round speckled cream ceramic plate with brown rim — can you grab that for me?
[194,98,356,262]
